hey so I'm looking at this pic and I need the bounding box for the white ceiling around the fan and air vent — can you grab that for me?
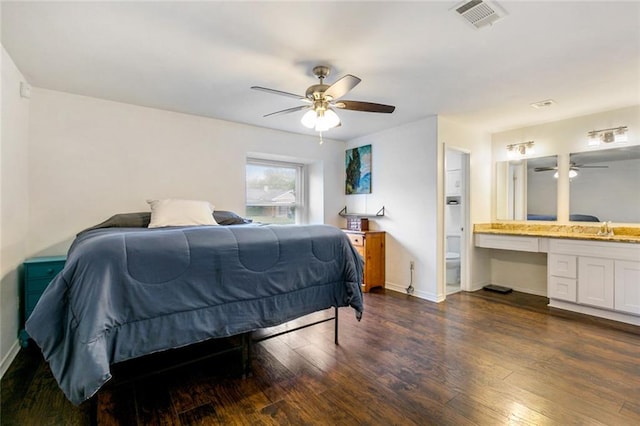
[1,1,640,140]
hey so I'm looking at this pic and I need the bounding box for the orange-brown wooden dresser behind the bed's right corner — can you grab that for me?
[343,229,385,292]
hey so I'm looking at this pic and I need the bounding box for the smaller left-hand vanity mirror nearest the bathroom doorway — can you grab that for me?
[496,155,558,220]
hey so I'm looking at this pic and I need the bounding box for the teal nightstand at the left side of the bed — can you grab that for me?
[18,256,67,348]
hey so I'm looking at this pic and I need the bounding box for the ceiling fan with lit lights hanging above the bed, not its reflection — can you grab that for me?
[251,65,396,132]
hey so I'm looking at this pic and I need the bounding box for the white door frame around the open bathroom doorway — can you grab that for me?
[440,144,471,299]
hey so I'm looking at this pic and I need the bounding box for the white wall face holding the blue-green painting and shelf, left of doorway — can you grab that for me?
[342,117,438,300]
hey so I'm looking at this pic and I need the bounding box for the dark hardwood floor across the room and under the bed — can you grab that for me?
[1,290,640,426]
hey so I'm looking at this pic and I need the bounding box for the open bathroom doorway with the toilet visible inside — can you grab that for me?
[444,147,469,295]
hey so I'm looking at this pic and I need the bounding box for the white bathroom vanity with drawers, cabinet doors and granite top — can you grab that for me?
[474,223,640,325]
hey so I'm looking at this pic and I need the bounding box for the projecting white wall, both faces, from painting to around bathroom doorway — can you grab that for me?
[347,117,491,301]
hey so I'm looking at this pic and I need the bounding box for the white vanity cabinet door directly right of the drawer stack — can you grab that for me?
[578,256,614,309]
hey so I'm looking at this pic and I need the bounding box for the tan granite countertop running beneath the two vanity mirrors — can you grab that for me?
[473,222,640,244]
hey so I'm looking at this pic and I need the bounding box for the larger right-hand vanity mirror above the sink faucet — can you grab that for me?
[569,145,640,223]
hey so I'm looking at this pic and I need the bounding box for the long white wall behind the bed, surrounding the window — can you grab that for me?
[28,88,344,255]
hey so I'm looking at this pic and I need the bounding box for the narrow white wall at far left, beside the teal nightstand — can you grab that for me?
[0,47,29,377]
